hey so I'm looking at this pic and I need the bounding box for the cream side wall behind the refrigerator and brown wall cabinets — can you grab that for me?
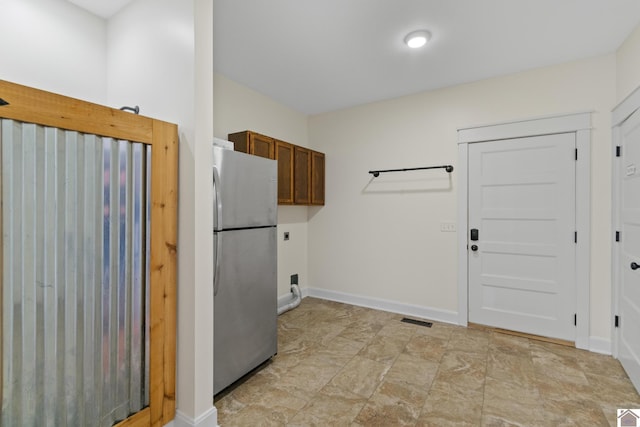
[214,74,308,297]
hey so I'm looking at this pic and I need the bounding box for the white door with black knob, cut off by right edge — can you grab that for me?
[615,108,640,390]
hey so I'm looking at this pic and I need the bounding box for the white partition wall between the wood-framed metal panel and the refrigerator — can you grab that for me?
[108,0,215,425]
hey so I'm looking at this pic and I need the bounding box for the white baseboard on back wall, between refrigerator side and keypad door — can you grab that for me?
[302,288,458,325]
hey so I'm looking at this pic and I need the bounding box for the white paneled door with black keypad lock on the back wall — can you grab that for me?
[468,133,576,341]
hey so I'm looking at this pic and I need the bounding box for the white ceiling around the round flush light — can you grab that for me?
[69,0,640,114]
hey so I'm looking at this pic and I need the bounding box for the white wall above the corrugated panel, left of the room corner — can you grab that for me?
[0,0,107,103]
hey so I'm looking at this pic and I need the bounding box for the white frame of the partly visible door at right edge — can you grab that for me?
[611,87,640,358]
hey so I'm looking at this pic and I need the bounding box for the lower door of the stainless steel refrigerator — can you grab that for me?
[213,227,278,393]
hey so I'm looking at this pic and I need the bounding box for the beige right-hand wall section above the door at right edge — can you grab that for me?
[616,26,640,102]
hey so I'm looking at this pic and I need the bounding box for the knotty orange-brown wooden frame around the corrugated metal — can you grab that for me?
[0,80,178,427]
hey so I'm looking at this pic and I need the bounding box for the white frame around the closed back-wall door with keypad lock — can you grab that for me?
[456,112,591,349]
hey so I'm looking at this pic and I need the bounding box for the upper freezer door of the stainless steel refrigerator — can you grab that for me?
[213,146,278,231]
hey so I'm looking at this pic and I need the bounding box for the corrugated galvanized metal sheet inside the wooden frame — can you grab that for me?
[0,120,151,426]
